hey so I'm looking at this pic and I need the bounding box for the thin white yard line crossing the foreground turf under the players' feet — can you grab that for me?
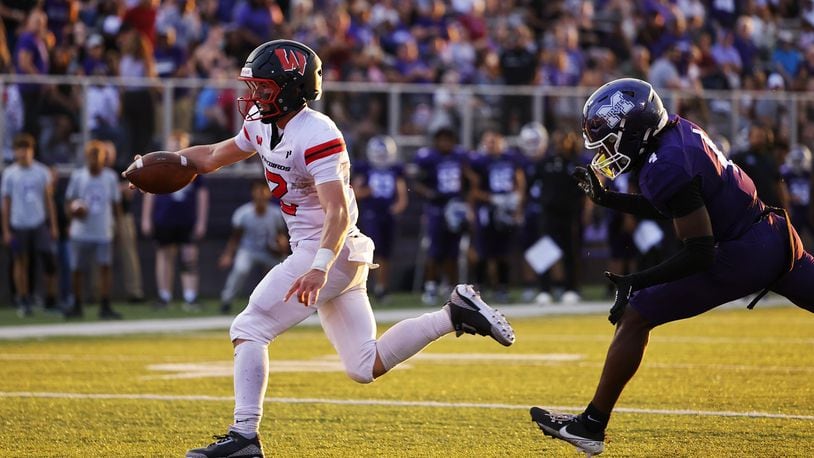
[0,391,814,421]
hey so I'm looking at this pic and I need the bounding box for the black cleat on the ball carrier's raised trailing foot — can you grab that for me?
[446,285,514,347]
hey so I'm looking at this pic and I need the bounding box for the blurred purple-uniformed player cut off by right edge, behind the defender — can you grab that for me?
[780,145,814,243]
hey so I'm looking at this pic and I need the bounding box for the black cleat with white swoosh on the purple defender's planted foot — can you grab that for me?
[529,407,605,457]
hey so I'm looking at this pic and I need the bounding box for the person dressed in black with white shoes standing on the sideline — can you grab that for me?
[536,132,585,303]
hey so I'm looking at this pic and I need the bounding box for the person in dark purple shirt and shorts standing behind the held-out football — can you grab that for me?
[141,132,209,311]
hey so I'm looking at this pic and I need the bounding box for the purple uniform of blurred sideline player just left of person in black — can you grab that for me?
[472,151,521,259]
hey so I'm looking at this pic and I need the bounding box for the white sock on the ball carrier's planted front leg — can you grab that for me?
[229,341,269,438]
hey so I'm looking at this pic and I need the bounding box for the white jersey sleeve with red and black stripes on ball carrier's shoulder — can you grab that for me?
[303,124,350,185]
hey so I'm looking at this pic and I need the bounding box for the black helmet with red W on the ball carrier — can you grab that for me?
[237,40,322,122]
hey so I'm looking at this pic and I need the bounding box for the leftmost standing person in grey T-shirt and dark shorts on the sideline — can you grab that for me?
[0,133,58,317]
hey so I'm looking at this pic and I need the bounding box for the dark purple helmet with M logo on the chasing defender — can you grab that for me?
[582,78,667,179]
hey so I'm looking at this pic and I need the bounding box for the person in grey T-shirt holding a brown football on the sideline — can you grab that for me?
[65,140,121,320]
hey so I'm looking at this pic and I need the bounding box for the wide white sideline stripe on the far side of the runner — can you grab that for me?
[0,296,789,340]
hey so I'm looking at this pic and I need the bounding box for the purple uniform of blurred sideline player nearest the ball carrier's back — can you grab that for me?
[354,162,404,259]
